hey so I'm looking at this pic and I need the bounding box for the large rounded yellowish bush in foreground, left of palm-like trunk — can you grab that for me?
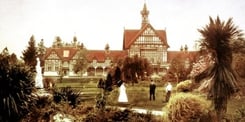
[167,93,211,122]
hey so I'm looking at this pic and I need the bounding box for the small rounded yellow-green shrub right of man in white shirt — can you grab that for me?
[176,80,193,92]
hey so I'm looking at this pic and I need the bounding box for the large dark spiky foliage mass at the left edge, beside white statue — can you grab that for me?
[0,50,34,121]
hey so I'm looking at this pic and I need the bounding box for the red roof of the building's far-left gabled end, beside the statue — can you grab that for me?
[44,47,78,61]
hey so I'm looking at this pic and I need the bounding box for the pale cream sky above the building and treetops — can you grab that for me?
[0,0,245,57]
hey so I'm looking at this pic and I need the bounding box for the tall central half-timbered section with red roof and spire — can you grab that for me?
[123,4,169,71]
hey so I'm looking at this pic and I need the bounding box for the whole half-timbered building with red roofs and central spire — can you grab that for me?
[43,4,195,77]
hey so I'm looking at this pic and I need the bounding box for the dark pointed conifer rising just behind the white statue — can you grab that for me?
[22,35,37,71]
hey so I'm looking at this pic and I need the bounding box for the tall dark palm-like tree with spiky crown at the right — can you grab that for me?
[195,17,242,121]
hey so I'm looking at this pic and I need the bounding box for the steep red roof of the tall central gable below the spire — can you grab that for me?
[123,24,169,50]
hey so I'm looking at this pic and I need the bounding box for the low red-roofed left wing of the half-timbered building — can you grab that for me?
[43,46,127,77]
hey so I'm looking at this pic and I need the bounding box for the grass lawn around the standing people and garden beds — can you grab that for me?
[56,78,245,118]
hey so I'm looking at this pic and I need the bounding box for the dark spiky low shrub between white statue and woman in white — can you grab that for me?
[53,87,80,107]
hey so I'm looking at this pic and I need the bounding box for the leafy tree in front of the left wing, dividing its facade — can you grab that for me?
[73,43,88,74]
